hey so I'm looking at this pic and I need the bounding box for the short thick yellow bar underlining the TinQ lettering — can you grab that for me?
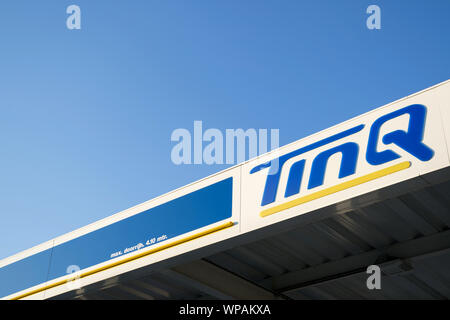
[259,161,411,217]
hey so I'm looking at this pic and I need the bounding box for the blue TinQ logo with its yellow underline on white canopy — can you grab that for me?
[250,104,434,217]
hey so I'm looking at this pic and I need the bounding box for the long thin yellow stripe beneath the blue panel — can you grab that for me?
[11,221,234,300]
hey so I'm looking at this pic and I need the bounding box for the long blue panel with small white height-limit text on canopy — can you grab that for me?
[0,177,233,296]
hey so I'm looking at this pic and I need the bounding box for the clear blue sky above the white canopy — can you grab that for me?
[0,0,450,258]
